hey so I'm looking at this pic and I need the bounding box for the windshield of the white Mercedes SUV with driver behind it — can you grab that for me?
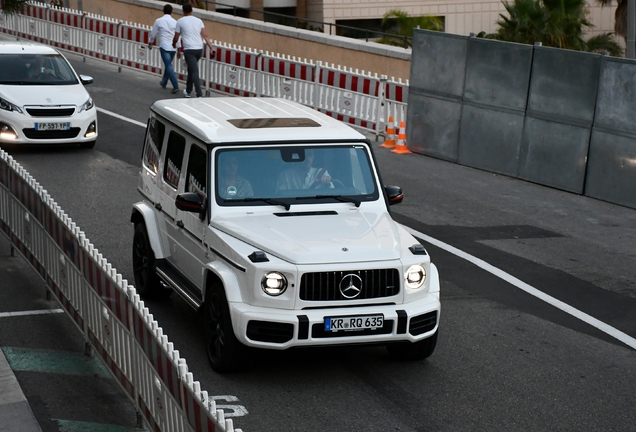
[214,144,379,209]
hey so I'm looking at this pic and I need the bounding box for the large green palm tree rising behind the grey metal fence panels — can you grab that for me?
[478,0,623,56]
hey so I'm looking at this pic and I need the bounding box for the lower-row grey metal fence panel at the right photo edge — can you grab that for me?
[585,129,636,208]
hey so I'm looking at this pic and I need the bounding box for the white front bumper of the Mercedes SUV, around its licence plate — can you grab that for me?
[230,293,440,350]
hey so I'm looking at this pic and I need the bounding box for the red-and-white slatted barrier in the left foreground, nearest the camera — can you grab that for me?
[0,149,240,432]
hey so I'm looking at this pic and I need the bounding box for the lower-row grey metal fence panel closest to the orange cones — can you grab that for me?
[406,88,462,162]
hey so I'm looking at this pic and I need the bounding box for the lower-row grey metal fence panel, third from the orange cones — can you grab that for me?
[519,116,590,194]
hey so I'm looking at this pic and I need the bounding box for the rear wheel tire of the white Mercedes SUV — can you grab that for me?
[132,223,171,299]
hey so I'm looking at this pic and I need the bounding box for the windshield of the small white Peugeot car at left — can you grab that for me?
[0,54,78,85]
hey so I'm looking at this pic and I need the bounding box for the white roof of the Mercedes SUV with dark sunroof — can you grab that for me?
[151,97,365,144]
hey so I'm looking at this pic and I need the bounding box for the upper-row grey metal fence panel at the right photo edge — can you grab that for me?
[594,57,636,134]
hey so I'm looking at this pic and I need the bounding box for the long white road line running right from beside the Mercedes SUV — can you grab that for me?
[404,226,636,349]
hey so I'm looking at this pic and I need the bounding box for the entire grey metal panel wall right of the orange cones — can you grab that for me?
[406,30,636,208]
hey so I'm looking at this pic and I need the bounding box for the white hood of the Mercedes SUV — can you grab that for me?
[211,210,400,264]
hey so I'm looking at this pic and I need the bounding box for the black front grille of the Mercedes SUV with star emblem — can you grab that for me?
[300,269,400,301]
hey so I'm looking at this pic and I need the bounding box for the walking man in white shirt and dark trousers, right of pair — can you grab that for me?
[172,3,214,97]
